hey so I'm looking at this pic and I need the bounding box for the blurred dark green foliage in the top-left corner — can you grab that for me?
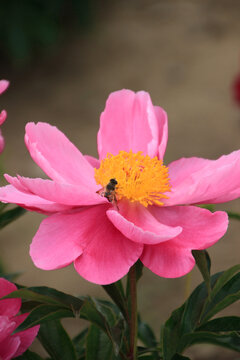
[0,0,98,66]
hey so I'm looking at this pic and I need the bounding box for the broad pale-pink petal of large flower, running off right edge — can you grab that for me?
[164,151,240,206]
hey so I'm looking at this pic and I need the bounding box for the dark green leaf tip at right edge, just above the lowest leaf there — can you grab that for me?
[197,316,240,332]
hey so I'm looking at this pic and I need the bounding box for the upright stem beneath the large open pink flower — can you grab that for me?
[129,265,137,360]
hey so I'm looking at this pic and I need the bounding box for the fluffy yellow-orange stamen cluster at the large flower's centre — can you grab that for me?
[95,151,170,207]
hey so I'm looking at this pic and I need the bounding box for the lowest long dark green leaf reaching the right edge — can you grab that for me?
[182,331,240,352]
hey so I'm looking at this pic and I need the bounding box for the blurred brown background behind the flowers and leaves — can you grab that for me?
[0,0,240,360]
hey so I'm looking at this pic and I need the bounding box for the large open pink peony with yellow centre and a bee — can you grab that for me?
[0,90,240,284]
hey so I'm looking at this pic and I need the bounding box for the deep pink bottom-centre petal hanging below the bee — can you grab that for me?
[74,205,143,285]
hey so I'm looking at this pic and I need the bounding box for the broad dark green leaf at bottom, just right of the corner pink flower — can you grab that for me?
[38,320,77,360]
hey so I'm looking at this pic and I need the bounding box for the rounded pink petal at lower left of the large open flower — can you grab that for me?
[30,211,82,270]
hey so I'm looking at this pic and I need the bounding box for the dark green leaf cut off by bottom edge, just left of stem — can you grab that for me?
[86,325,117,360]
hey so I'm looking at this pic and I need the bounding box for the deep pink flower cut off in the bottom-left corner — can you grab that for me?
[0,278,39,360]
